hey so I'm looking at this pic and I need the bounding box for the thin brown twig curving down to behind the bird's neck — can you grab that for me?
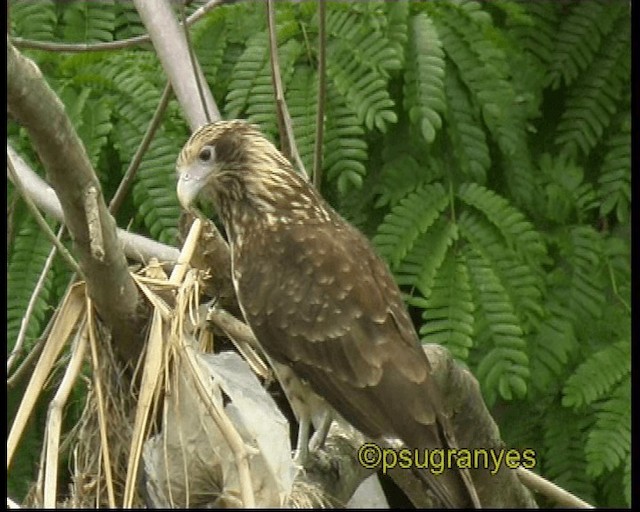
[267,0,309,178]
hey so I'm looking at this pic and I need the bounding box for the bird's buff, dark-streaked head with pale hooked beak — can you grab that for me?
[176,120,330,223]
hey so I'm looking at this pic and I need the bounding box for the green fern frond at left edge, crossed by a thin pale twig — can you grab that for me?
[7,217,53,352]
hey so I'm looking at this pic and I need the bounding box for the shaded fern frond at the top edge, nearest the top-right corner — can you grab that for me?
[547,0,628,89]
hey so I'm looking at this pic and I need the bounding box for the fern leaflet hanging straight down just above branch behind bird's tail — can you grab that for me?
[420,253,475,361]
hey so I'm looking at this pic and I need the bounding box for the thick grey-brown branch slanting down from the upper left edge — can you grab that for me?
[7,41,145,362]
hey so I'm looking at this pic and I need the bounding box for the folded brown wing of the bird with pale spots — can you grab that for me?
[234,222,438,445]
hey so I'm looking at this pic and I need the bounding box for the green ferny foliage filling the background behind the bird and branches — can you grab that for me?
[7,0,631,506]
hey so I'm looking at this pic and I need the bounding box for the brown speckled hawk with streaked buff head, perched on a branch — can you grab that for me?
[176,119,480,508]
